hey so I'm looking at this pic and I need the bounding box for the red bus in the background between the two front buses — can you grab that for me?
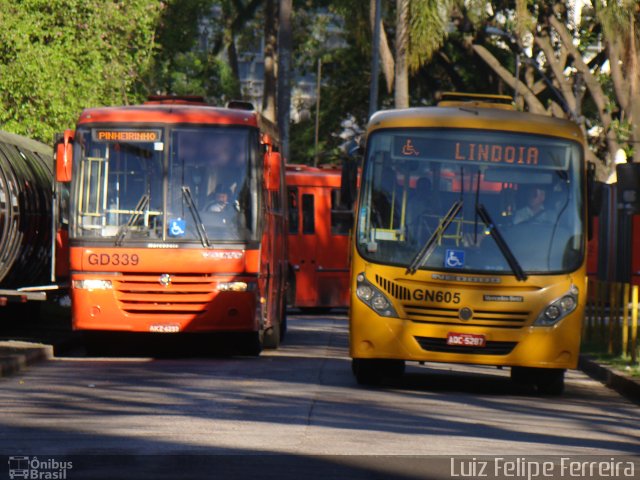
[286,165,353,310]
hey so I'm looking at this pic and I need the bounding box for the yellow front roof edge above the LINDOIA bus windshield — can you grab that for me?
[367,104,583,142]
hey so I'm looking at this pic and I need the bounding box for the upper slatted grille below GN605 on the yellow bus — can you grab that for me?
[402,304,529,329]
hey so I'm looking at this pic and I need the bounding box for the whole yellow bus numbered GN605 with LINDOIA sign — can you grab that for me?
[349,96,587,394]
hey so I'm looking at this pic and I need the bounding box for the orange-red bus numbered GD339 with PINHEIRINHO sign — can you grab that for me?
[56,97,288,354]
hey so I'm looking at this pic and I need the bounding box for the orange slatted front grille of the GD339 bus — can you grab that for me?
[113,274,216,316]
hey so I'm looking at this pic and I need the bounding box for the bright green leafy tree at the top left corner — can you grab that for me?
[0,0,164,143]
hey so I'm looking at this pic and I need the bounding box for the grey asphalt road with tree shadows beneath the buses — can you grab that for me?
[0,315,640,479]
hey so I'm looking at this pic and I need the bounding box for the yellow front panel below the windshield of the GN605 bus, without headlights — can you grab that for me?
[349,259,586,368]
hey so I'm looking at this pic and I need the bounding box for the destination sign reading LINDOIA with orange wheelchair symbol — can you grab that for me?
[393,135,569,169]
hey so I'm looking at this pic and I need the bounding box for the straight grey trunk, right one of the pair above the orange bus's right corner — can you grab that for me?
[278,0,293,160]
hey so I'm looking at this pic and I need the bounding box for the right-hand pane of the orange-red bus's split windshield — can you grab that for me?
[167,127,259,243]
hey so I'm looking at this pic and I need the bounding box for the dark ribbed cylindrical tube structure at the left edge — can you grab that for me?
[0,131,53,289]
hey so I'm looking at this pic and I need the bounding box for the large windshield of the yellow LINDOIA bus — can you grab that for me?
[357,128,584,280]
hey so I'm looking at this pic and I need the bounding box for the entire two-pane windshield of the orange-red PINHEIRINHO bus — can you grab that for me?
[70,126,260,247]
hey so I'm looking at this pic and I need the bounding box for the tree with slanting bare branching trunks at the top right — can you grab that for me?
[464,0,638,178]
